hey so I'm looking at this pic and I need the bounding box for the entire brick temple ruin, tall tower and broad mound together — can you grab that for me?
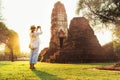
[39,1,118,63]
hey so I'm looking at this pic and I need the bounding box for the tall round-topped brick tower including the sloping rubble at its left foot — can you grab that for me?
[39,1,68,62]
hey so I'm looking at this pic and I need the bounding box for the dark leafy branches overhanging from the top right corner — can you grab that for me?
[77,0,120,24]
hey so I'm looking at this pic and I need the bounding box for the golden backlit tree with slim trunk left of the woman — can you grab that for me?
[0,22,20,61]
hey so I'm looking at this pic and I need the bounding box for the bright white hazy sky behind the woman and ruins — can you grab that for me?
[2,0,111,52]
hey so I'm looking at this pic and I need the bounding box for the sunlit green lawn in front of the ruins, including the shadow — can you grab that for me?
[0,61,120,80]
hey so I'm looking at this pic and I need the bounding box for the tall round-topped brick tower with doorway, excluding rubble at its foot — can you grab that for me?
[50,1,68,49]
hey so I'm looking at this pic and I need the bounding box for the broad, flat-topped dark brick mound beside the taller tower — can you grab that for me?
[54,17,117,63]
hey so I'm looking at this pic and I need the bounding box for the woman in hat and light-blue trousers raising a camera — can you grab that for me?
[29,25,42,69]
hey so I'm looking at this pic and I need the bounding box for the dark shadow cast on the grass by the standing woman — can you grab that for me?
[31,69,64,80]
